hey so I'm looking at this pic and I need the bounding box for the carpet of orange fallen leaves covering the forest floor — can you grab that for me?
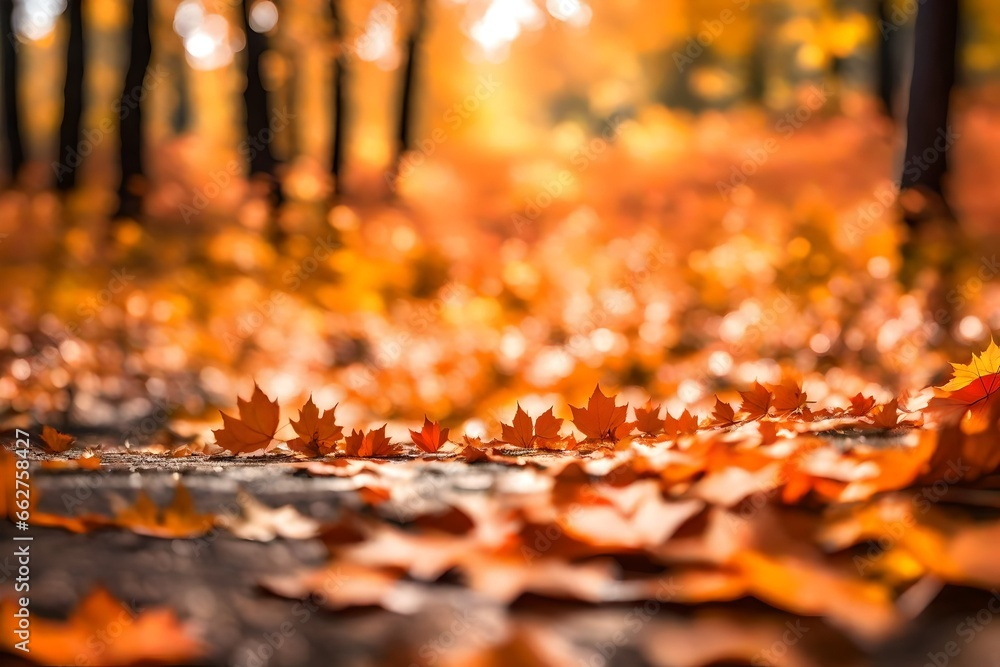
[0,101,1000,667]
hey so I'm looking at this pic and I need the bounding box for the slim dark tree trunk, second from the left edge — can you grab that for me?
[56,0,84,191]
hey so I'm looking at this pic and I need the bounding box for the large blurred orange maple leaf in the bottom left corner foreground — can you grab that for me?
[0,588,204,667]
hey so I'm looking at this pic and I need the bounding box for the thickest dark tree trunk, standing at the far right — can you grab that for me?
[900,0,958,200]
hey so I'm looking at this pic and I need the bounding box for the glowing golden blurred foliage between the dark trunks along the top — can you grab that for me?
[7,0,1000,200]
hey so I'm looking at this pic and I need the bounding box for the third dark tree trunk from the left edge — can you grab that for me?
[118,0,153,216]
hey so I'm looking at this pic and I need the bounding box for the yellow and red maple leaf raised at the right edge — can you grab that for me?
[927,338,1000,433]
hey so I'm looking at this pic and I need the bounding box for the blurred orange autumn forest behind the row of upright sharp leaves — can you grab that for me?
[0,0,1000,437]
